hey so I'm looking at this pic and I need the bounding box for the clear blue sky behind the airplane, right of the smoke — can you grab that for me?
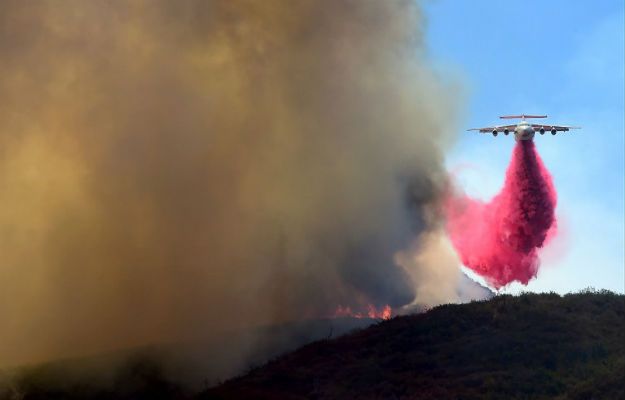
[425,0,625,293]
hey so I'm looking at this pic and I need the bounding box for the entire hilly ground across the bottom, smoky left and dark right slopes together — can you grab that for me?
[0,291,625,400]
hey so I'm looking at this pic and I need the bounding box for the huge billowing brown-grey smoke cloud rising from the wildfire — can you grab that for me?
[0,0,458,365]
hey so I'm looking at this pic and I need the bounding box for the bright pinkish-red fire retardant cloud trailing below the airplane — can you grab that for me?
[445,141,556,289]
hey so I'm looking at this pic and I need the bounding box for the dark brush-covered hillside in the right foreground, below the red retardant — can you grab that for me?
[200,291,625,400]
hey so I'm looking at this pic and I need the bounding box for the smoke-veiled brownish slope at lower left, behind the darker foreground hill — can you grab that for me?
[0,317,377,400]
